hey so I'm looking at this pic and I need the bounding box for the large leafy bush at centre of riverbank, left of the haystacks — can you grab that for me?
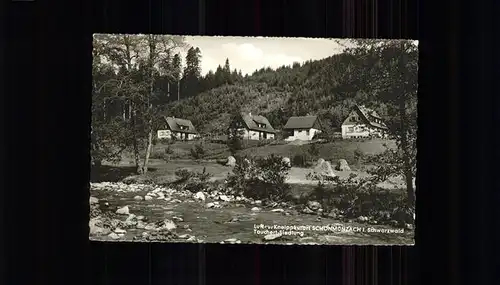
[228,155,290,201]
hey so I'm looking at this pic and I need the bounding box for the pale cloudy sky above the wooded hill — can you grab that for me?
[182,36,350,75]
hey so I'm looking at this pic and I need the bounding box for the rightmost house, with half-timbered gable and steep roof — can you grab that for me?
[342,105,388,139]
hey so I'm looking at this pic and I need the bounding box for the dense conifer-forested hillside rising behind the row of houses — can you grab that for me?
[165,41,417,136]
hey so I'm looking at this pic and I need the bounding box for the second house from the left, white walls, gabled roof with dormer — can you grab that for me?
[228,112,276,140]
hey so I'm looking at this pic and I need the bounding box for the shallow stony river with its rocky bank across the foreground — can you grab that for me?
[89,182,413,244]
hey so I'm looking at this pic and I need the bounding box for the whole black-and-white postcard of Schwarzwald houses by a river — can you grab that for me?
[89,34,418,245]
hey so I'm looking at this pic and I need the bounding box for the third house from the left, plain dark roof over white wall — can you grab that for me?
[283,116,323,141]
